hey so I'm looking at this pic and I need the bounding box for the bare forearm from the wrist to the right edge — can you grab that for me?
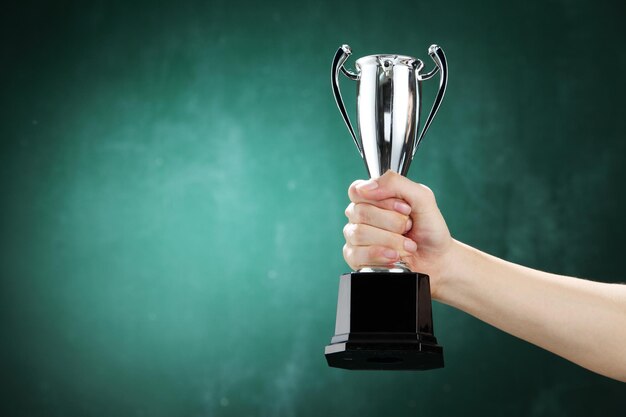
[434,241,626,382]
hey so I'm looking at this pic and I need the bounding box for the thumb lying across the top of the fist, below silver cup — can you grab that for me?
[355,171,437,213]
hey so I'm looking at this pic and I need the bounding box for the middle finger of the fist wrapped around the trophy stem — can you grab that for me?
[345,202,413,235]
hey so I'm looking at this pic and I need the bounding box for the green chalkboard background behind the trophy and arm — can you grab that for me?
[0,0,626,417]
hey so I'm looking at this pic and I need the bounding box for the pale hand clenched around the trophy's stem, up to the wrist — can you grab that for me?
[343,171,454,297]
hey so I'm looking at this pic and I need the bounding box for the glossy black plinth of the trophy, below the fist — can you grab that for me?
[325,272,443,370]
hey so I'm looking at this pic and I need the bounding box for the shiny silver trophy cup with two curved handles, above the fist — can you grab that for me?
[331,45,448,178]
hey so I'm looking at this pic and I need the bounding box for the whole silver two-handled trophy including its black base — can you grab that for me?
[325,45,448,370]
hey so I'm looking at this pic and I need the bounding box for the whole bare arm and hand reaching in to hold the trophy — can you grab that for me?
[343,172,626,382]
